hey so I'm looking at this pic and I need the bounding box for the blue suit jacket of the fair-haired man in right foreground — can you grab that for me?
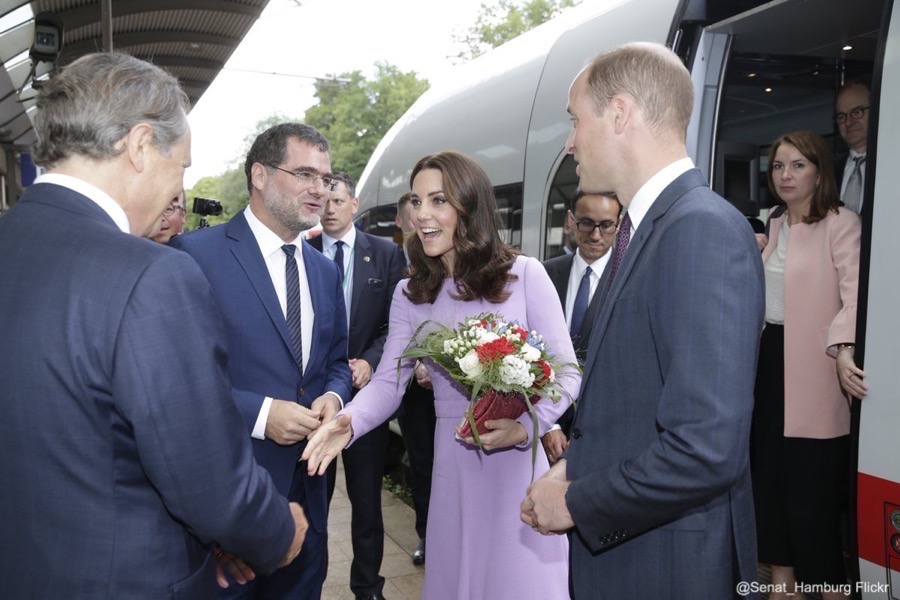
[566,169,764,600]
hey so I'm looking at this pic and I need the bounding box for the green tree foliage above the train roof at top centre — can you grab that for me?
[456,0,580,61]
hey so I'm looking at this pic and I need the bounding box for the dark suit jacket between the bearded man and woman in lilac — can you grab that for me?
[309,231,406,384]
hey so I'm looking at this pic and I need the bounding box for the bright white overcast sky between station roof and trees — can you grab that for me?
[185,0,496,188]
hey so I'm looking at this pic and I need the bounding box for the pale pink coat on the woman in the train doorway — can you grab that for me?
[762,208,860,439]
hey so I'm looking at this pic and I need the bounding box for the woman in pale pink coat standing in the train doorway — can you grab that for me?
[753,131,866,599]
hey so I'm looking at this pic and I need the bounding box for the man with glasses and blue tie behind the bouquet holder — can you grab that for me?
[541,188,622,463]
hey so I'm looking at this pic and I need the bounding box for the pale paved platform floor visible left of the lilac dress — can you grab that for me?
[322,454,425,600]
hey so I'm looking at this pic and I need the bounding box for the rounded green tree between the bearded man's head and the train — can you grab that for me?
[304,62,428,180]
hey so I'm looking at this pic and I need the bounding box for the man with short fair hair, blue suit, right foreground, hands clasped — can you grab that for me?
[522,43,764,600]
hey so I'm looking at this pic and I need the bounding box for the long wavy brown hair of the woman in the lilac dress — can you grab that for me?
[405,151,518,304]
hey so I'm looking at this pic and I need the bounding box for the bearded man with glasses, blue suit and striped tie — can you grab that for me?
[170,123,350,600]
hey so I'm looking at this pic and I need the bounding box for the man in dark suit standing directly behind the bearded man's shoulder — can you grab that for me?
[309,172,405,600]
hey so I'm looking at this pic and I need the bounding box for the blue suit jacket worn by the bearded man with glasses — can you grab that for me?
[169,211,350,532]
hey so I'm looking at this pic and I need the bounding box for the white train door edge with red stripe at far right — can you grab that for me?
[854,3,900,600]
